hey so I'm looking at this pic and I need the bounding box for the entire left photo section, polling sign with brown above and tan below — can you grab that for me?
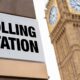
[0,0,48,80]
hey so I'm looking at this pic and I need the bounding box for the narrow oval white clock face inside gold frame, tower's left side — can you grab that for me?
[49,6,58,25]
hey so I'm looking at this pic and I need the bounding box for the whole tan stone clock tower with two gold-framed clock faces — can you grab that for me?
[46,0,80,80]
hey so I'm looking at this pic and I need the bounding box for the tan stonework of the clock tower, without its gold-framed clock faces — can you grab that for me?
[46,0,80,80]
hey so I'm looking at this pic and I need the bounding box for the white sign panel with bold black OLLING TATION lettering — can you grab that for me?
[0,13,44,62]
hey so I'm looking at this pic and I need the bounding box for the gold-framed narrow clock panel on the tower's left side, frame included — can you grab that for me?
[46,0,61,33]
